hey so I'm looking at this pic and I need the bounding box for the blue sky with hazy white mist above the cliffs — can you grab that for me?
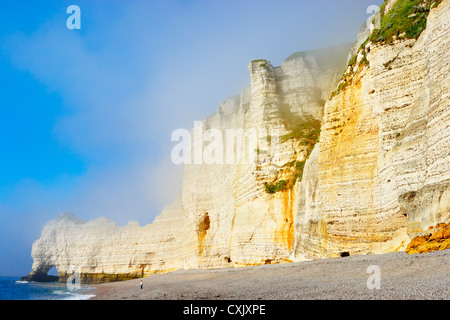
[0,0,382,276]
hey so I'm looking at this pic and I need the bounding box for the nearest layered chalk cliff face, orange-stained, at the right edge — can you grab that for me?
[317,1,450,253]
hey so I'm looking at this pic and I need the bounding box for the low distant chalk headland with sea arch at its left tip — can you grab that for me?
[25,203,183,283]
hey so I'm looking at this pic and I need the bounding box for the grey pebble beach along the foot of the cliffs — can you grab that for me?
[89,250,450,300]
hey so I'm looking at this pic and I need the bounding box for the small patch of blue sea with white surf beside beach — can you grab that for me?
[0,277,94,300]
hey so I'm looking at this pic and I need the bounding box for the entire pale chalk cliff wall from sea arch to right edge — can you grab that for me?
[23,0,450,281]
